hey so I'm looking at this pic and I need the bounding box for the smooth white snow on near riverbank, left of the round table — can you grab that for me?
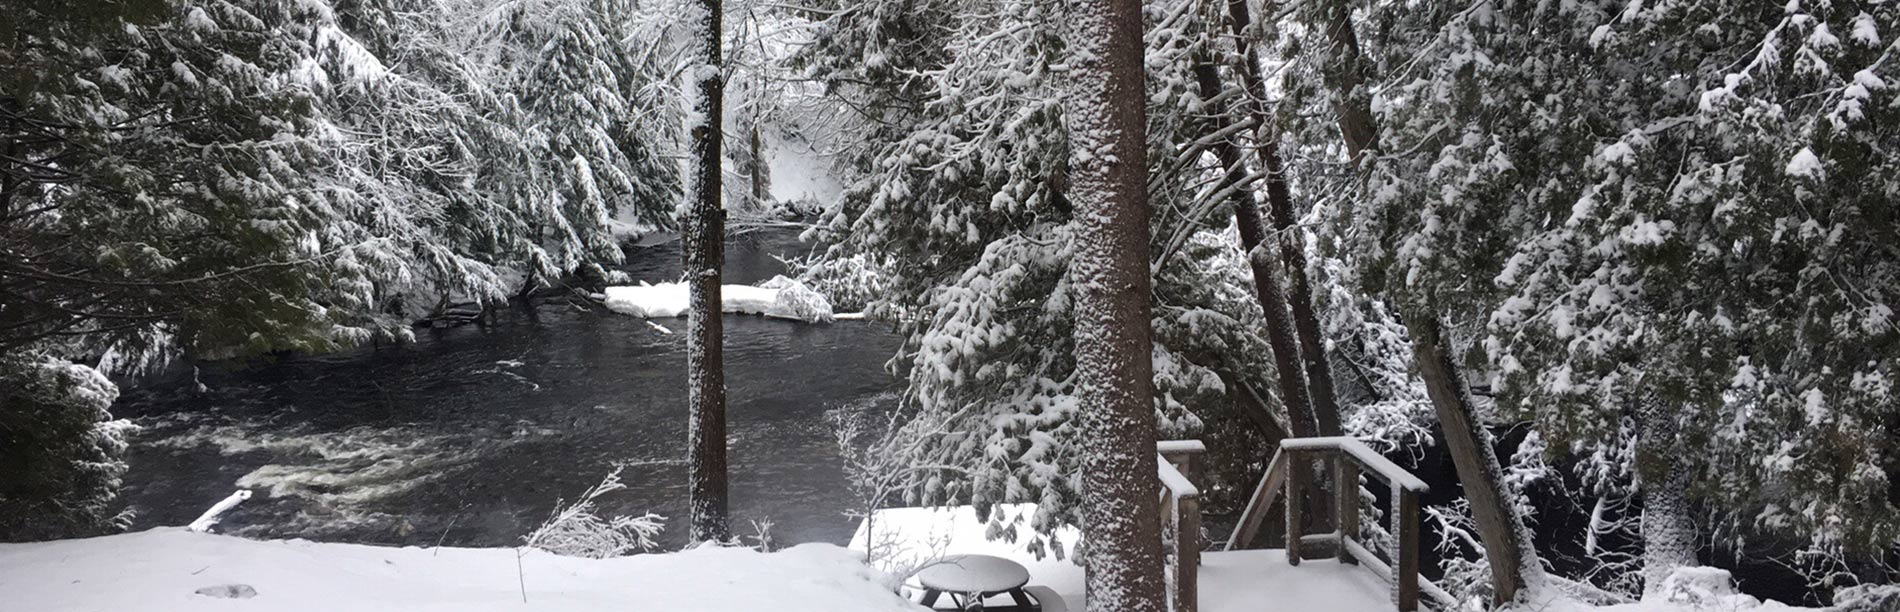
[0,528,918,612]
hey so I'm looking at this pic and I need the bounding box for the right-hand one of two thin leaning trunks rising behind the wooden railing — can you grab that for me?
[1227,0,1345,435]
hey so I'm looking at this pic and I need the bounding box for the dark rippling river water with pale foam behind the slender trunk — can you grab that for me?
[116,232,903,545]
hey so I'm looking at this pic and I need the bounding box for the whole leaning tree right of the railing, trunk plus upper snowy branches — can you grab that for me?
[1269,2,1543,602]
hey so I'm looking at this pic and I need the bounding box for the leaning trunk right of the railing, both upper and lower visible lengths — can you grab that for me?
[1307,0,1543,602]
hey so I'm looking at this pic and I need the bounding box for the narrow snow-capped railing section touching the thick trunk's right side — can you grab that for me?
[1155,439,1207,612]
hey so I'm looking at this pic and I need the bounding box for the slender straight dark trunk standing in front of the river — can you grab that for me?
[680,0,730,544]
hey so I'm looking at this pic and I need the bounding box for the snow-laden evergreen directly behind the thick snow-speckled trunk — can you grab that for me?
[800,2,1314,528]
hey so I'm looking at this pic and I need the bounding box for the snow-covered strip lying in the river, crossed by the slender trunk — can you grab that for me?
[604,276,832,323]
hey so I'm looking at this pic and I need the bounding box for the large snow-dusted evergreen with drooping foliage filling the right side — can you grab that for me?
[1340,2,1900,596]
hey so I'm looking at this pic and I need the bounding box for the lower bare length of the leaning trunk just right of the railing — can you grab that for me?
[1406,308,1541,602]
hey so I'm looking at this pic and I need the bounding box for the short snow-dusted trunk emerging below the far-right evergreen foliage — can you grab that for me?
[1636,395,1697,595]
